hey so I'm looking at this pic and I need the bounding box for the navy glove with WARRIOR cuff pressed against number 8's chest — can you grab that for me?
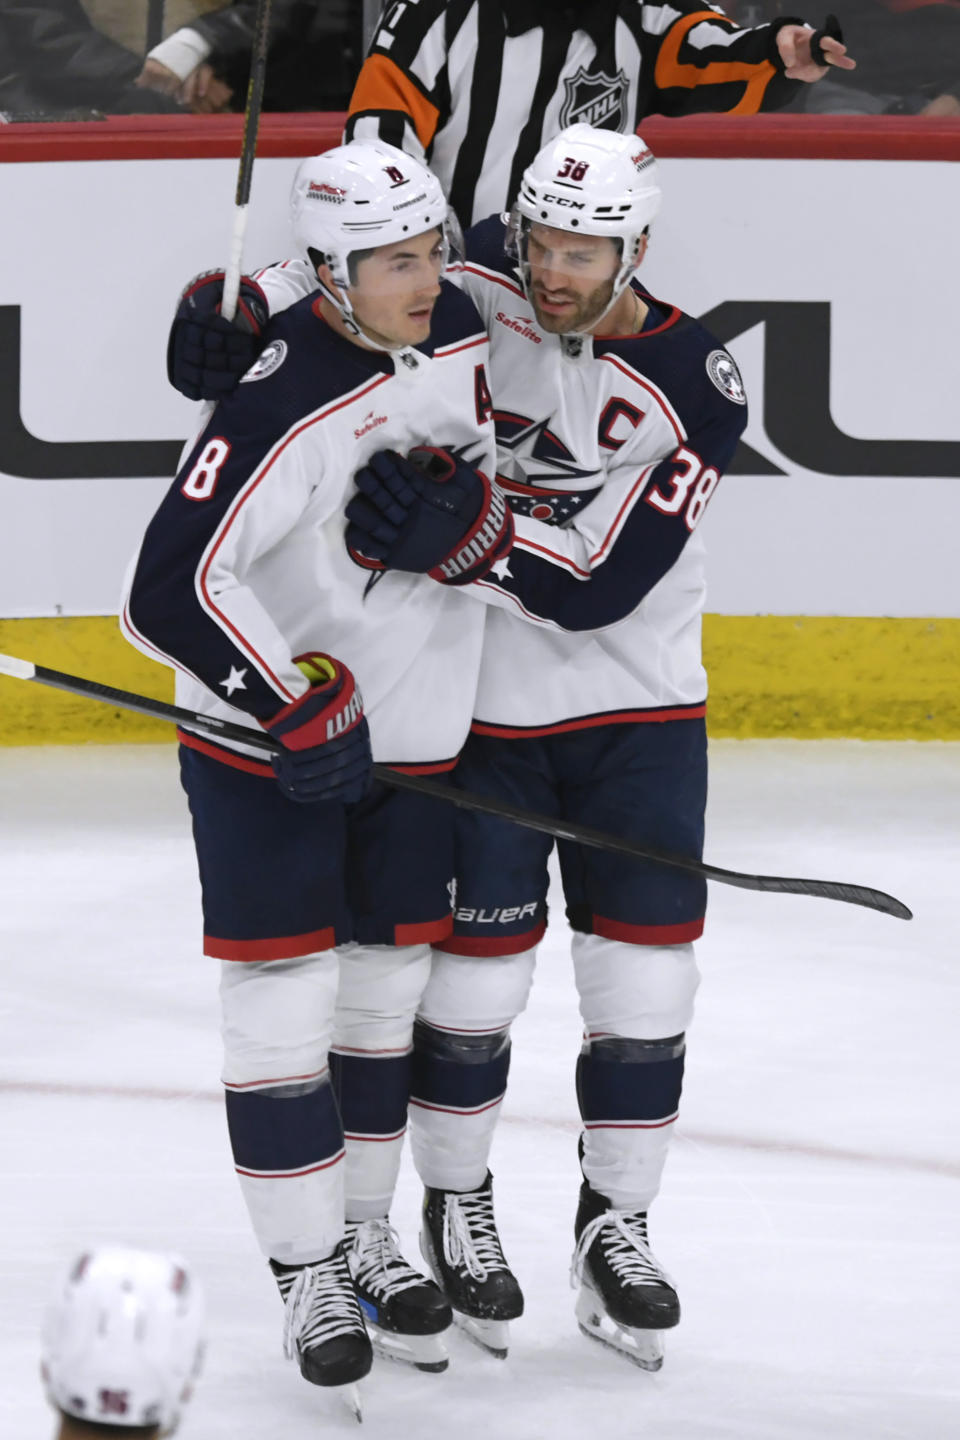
[347,446,514,585]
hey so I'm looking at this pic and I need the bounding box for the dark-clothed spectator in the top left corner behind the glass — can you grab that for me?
[0,0,180,120]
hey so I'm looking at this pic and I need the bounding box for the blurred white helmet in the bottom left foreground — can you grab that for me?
[40,1246,203,1434]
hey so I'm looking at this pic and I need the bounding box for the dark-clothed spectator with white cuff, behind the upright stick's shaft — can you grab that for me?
[137,0,363,112]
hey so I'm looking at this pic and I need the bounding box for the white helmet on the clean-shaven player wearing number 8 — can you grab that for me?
[291,140,462,342]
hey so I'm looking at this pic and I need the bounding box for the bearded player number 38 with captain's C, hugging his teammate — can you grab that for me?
[163,127,746,1367]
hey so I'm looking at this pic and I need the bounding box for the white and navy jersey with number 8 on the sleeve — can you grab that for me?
[121,284,494,769]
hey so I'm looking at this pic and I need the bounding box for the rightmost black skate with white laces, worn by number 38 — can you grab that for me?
[570,1181,679,1369]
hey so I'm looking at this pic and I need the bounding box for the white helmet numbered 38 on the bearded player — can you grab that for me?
[507,125,661,326]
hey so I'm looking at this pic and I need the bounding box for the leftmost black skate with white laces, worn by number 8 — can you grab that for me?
[271,1244,373,1418]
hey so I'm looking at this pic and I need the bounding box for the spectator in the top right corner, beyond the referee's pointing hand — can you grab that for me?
[725,0,960,117]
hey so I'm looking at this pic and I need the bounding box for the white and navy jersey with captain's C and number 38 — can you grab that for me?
[236,230,747,736]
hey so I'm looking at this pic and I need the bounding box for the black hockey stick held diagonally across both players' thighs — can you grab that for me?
[0,654,913,920]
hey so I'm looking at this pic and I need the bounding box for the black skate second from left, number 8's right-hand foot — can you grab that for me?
[344,1220,453,1372]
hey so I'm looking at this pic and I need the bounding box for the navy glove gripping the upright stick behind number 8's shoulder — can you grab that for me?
[167,271,271,400]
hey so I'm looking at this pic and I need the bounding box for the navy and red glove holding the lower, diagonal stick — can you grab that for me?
[261,651,373,805]
